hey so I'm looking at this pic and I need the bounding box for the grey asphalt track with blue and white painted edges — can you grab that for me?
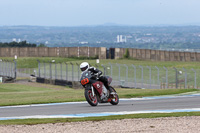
[0,94,200,120]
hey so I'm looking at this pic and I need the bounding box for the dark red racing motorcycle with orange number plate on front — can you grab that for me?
[80,71,119,106]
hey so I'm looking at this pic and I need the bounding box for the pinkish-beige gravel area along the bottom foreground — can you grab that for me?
[0,116,200,133]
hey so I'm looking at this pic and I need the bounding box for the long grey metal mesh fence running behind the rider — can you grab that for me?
[37,61,200,89]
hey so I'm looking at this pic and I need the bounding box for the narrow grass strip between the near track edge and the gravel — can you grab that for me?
[0,112,200,125]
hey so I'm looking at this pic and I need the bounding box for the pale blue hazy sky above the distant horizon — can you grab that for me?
[0,0,200,26]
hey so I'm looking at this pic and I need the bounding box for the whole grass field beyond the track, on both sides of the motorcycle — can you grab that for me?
[0,82,199,106]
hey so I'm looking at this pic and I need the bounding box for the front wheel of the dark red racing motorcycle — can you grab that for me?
[85,89,98,106]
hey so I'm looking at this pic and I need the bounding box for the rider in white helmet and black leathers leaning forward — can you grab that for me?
[80,62,114,94]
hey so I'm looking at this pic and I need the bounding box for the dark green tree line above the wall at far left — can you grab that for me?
[0,41,46,47]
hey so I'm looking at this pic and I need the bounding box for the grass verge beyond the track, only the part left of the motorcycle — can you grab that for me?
[0,83,84,106]
